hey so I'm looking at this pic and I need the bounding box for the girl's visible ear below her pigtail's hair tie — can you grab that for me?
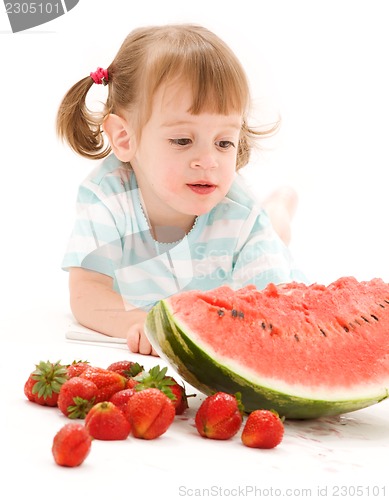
[103,114,136,162]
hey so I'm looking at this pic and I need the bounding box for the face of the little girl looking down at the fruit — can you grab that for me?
[131,84,242,231]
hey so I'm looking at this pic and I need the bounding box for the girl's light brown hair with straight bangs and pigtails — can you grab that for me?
[57,24,278,169]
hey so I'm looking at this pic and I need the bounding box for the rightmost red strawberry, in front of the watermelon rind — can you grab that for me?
[241,410,284,448]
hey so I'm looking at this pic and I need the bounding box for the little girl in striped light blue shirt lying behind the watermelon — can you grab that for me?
[57,25,304,355]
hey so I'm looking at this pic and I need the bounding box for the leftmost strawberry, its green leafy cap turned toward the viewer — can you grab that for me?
[24,361,67,406]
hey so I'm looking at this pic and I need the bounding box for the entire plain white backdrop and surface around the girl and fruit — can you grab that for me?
[0,4,389,499]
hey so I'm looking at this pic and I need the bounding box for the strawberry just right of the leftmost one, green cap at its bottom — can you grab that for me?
[58,377,98,418]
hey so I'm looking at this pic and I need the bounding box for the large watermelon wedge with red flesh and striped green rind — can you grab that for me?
[146,277,389,419]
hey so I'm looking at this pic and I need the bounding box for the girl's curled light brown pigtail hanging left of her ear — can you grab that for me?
[56,76,111,160]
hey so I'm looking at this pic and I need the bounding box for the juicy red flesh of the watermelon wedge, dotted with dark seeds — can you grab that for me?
[170,279,389,393]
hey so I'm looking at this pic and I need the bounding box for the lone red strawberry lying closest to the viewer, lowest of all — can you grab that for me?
[51,423,92,467]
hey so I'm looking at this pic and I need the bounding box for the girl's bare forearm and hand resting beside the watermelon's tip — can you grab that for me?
[69,267,158,356]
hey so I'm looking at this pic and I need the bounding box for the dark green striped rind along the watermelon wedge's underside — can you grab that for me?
[145,300,389,419]
